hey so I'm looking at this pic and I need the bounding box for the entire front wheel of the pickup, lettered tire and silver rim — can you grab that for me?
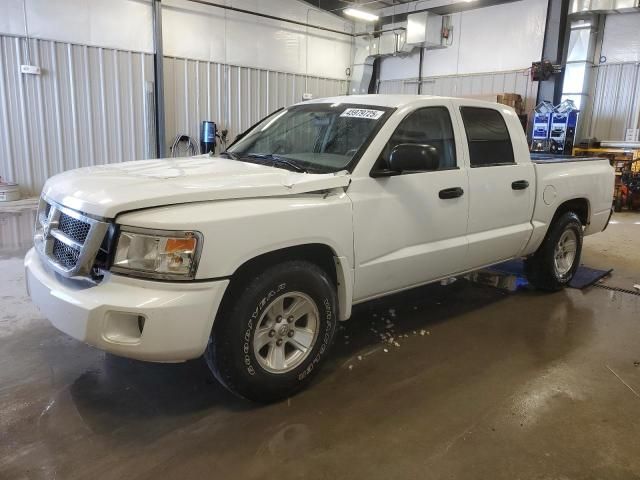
[205,261,337,402]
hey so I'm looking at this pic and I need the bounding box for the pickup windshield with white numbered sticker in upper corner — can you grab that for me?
[227,103,391,172]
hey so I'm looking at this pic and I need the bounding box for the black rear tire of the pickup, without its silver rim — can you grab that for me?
[524,212,583,292]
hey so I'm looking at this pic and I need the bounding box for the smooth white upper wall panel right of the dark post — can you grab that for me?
[162,0,354,79]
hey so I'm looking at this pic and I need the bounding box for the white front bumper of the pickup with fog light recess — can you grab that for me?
[25,248,229,362]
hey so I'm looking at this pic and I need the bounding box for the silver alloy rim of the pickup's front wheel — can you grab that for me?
[253,292,320,373]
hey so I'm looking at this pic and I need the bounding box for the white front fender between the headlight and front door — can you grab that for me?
[116,190,354,285]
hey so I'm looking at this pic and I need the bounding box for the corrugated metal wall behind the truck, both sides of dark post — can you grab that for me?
[0,36,347,195]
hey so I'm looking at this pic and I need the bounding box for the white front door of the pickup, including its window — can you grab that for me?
[348,105,469,301]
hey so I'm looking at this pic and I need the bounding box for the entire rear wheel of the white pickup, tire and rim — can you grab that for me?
[524,212,583,292]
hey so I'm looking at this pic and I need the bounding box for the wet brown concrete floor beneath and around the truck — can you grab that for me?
[0,203,640,480]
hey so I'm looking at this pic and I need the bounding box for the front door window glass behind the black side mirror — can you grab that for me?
[377,107,457,170]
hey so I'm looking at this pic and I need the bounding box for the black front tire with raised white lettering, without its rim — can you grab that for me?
[205,261,337,403]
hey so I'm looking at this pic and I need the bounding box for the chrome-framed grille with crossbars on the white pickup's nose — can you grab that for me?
[34,198,110,278]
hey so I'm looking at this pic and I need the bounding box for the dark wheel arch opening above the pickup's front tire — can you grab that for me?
[223,243,353,320]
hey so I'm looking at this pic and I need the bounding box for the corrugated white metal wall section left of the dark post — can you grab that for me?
[0,36,154,195]
